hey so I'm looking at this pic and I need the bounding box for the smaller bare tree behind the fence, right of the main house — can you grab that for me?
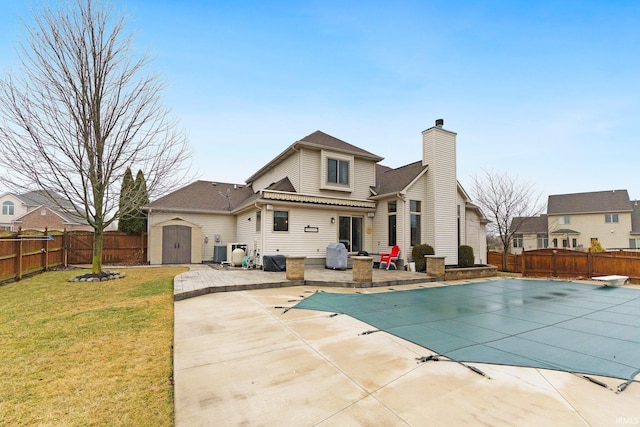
[471,170,541,271]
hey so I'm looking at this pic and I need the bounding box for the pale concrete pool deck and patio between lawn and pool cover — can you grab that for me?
[174,266,640,427]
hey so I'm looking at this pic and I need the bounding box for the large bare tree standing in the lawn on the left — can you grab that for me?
[0,0,189,274]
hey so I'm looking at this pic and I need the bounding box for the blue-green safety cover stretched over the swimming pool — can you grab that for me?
[293,279,640,380]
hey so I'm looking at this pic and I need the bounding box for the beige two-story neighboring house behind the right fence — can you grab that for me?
[512,190,640,253]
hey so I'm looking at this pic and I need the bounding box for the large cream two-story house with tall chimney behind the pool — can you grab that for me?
[144,120,487,265]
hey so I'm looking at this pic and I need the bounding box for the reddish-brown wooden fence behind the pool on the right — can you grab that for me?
[487,248,640,283]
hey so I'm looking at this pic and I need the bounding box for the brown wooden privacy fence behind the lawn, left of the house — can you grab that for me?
[0,231,147,282]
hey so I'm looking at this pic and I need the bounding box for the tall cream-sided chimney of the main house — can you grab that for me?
[423,128,458,265]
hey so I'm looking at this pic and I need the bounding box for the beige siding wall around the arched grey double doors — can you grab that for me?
[149,212,236,261]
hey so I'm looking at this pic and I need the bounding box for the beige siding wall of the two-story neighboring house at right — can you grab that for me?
[548,212,631,250]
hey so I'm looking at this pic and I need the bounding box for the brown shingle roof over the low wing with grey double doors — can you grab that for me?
[146,181,254,212]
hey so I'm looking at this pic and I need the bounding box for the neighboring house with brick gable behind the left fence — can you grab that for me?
[0,191,92,231]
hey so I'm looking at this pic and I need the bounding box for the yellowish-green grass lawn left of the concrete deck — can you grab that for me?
[0,267,185,426]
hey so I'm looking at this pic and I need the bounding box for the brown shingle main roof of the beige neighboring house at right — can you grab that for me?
[547,190,631,215]
